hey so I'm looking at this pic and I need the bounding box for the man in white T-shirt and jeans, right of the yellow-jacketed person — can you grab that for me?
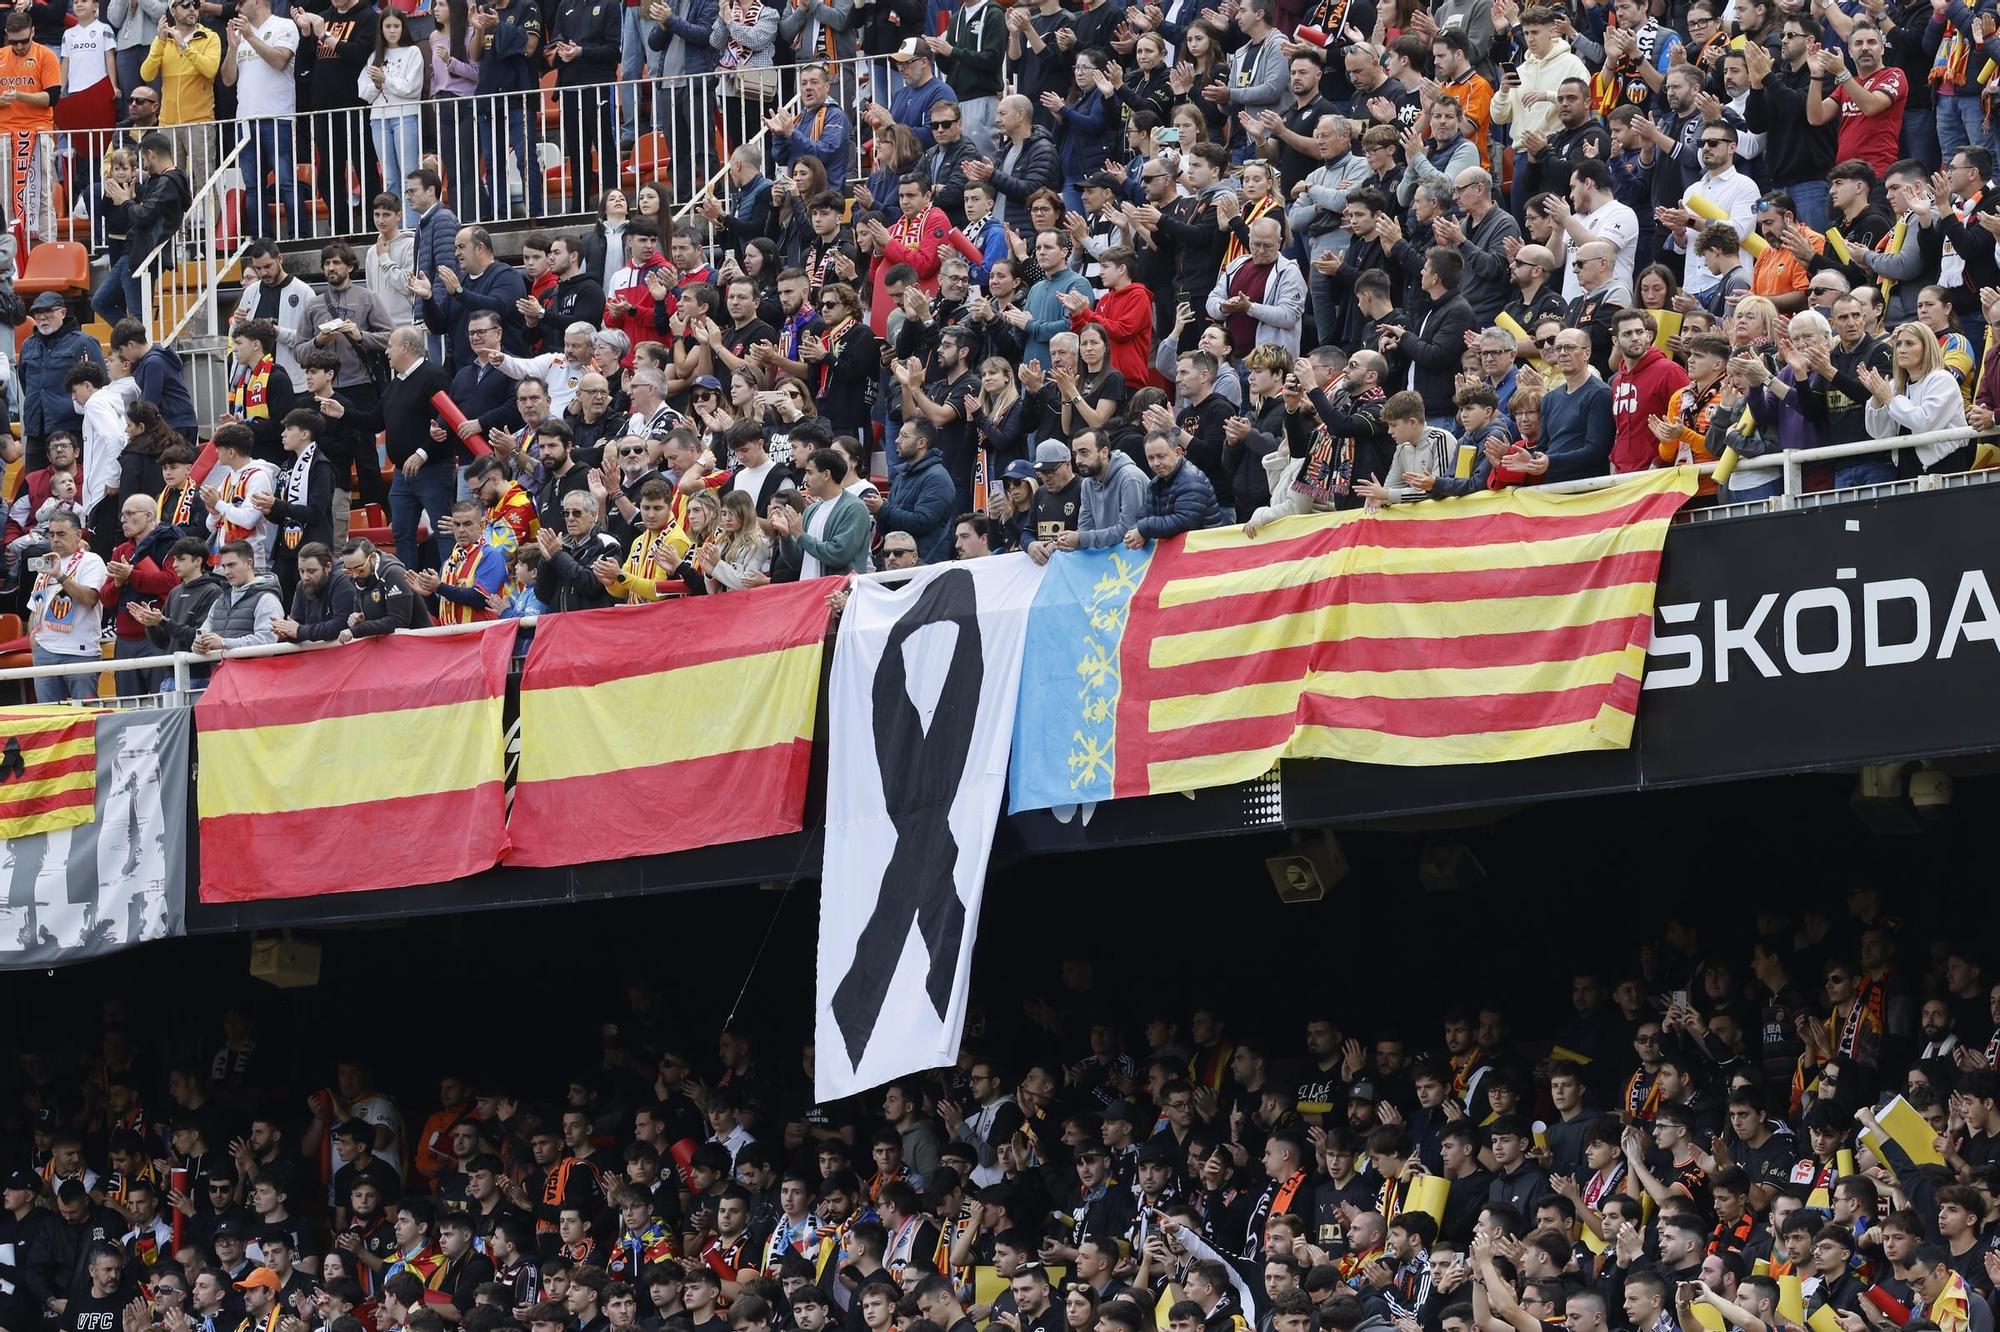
[222,0,304,236]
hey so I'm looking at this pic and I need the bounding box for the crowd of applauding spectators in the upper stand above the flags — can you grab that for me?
[0,0,2000,698]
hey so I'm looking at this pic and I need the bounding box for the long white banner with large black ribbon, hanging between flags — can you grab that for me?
[814,554,1042,1104]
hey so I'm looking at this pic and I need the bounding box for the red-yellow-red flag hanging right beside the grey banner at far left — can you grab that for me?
[194,620,514,902]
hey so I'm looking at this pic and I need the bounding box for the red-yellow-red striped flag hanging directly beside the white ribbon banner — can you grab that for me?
[506,580,838,866]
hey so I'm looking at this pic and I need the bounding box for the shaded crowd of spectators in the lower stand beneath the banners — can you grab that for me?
[0,888,2000,1332]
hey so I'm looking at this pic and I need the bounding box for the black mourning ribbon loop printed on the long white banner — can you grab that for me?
[834,568,986,1068]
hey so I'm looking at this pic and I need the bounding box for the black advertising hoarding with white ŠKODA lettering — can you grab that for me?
[1638,484,2000,786]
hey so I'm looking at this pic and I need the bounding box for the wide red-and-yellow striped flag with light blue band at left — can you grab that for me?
[1012,468,1696,812]
